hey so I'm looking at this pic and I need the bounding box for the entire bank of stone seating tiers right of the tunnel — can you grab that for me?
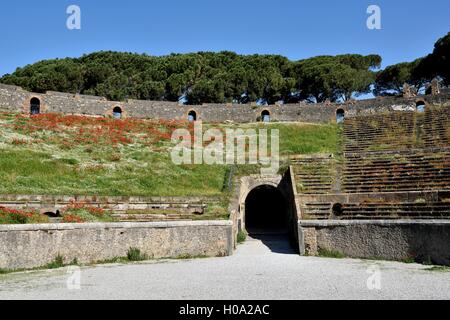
[292,106,450,219]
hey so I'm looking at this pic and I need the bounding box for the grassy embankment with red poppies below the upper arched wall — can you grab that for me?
[0,114,339,222]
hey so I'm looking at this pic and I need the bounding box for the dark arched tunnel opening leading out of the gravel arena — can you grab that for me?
[245,185,289,234]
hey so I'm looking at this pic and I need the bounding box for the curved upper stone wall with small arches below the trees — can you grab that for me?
[0,84,450,123]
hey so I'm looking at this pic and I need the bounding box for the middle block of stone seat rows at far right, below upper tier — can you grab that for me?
[342,148,450,193]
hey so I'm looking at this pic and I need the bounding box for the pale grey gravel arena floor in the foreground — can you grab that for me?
[0,236,450,300]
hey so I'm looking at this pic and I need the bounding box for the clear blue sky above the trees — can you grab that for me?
[0,0,450,75]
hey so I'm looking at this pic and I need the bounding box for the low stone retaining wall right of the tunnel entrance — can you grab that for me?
[298,220,450,265]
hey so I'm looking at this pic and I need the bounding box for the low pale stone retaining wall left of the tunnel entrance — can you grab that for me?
[0,221,234,270]
